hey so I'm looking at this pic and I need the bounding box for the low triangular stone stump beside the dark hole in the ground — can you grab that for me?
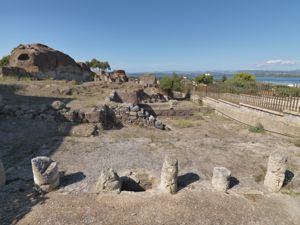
[95,168,121,193]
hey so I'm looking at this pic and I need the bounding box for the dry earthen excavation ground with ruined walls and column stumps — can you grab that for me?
[0,81,300,225]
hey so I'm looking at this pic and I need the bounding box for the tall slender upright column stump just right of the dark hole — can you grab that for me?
[160,156,178,194]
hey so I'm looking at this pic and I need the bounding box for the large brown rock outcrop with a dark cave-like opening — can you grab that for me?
[2,44,93,81]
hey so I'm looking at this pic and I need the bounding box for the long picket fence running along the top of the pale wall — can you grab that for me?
[194,85,300,113]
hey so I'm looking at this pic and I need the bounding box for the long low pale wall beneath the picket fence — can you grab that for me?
[202,97,300,136]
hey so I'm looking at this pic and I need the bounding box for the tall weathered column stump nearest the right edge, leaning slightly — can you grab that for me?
[264,151,288,192]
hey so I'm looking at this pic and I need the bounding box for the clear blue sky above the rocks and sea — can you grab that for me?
[0,0,300,72]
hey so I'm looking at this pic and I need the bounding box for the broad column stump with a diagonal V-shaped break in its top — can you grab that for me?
[31,156,59,192]
